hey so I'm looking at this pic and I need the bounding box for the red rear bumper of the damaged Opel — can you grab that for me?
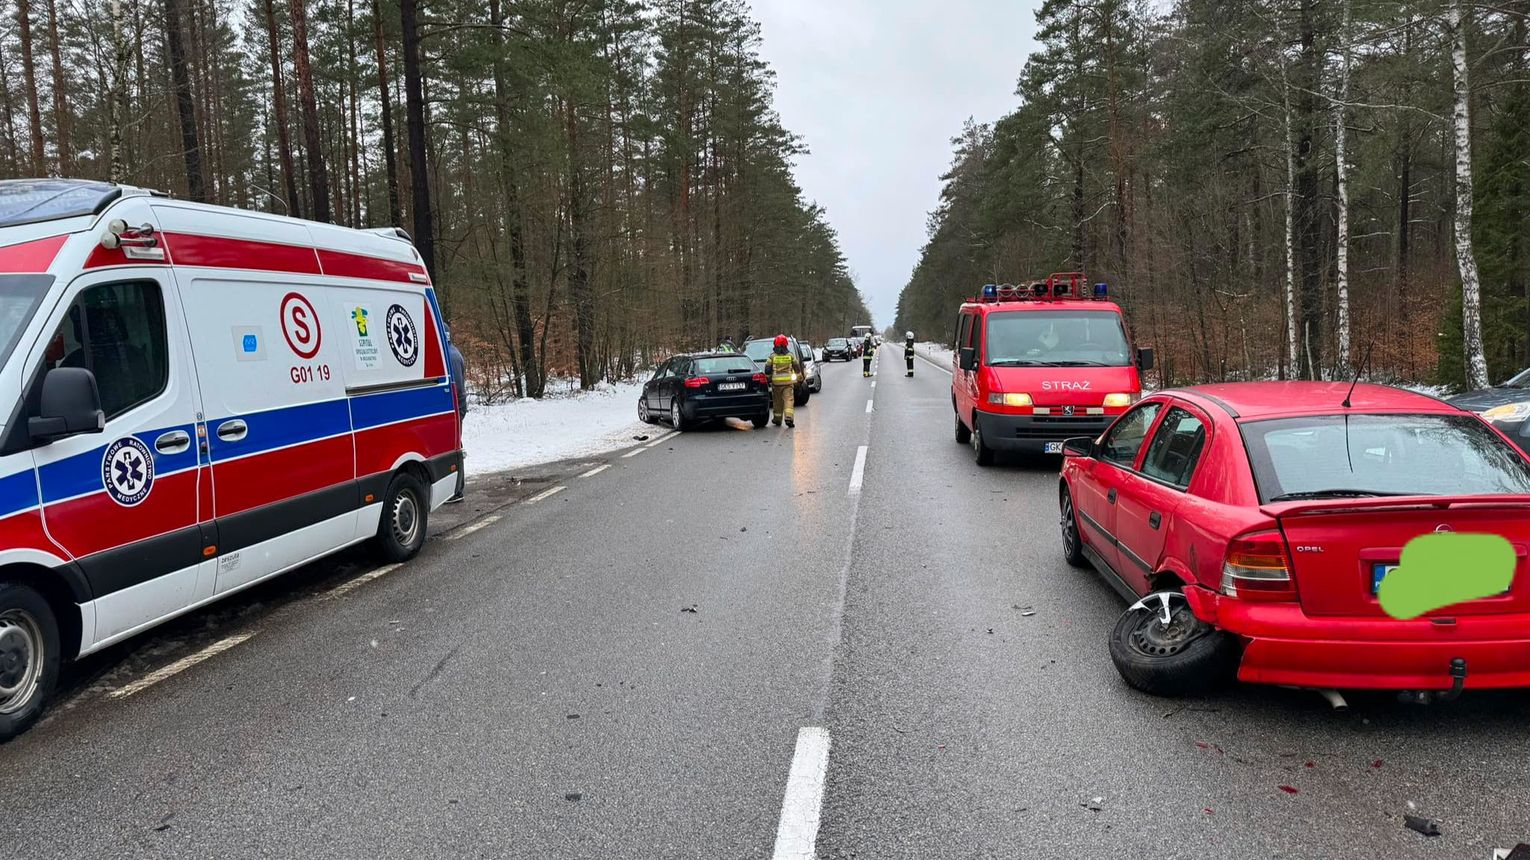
[1187,589,1530,690]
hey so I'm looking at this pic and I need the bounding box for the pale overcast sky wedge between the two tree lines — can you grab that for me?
[750,0,1040,326]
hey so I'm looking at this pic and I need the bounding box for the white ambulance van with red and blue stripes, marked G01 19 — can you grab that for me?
[0,179,462,741]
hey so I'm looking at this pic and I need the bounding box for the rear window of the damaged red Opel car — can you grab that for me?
[1241,415,1530,502]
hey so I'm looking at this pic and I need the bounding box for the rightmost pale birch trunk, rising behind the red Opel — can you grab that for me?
[1446,0,1489,389]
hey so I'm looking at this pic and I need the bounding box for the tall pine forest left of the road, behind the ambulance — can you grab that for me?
[0,0,869,401]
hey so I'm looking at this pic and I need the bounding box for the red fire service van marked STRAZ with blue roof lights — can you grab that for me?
[952,272,1154,465]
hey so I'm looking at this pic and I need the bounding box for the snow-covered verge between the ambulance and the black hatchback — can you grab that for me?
[462,383,645,480]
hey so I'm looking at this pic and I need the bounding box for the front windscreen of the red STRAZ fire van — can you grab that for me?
[984,311,1131,367]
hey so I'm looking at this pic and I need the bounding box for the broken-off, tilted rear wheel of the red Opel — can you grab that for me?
[1111,591,1238,696]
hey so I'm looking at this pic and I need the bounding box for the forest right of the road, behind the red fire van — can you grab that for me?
[895,0,1530,389]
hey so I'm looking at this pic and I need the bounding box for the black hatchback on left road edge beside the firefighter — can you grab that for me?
[638,352,770,430]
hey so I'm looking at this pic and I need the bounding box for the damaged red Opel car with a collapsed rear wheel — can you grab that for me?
[1059,383,1530,704]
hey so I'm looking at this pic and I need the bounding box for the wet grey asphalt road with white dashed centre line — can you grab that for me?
[0,344,1530,858]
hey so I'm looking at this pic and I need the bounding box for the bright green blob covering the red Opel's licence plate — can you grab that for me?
[1377,533,1515,621]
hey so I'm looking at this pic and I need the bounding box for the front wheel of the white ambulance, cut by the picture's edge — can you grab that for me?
[0,583,61,742]
